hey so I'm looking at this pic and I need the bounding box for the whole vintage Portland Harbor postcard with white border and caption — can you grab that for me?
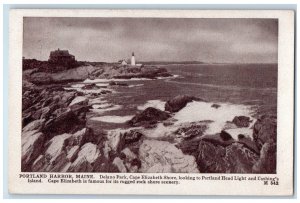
[9,9,294,196]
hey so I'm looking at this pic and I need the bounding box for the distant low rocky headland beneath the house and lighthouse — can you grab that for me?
[23,63,172,85]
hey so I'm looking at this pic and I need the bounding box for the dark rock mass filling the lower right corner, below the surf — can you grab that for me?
[176,116,276,173]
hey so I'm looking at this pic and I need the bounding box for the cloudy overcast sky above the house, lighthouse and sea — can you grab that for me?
[23,17,278,63]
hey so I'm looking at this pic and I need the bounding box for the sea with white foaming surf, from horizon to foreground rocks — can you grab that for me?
[77,64,277,136]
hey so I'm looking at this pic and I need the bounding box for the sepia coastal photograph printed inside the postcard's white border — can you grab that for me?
[20,17,278,173]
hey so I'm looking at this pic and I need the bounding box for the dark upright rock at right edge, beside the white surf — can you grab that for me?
[253,115,277,149]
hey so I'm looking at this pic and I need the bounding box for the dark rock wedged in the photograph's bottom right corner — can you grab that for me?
[253,142,277,174]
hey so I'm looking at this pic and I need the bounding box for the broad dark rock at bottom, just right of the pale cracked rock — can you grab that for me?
[197,140,258,173]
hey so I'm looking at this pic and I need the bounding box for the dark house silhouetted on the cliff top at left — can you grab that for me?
[48,49,76,67]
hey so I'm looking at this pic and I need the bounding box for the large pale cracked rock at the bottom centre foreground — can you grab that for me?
[139,140,199,173]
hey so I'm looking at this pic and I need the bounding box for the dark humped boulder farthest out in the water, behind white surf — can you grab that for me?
[165,95,203,112]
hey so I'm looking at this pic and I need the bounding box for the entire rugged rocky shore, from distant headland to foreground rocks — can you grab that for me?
[22,63,277,173]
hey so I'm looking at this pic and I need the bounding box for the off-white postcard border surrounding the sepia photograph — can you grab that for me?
[9,9,294,195]
